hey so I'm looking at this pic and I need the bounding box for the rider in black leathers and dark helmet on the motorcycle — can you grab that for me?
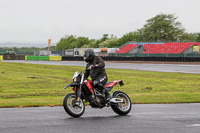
[83,49,110,100]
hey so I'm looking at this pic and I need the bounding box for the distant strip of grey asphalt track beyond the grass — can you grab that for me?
[3,60,200,74]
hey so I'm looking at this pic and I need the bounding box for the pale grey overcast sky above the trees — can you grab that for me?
[0,0,200,42]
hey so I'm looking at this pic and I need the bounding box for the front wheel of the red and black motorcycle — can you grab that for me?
[63,93,85,117]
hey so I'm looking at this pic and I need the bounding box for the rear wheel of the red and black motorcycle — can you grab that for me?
[111,91,132,115]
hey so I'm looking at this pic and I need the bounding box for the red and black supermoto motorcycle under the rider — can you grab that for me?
[63,70,132,117]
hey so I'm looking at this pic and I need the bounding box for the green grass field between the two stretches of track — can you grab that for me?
[0,62,200,108]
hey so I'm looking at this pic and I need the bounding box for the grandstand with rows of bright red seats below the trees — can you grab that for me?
[116,42,200,54]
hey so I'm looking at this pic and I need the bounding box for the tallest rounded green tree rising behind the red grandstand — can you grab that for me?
[141,14,185,42]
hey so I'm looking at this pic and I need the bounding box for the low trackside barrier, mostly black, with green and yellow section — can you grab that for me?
[0,55,200,62]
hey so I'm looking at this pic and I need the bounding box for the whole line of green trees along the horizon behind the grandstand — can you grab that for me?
[55,14,200,51]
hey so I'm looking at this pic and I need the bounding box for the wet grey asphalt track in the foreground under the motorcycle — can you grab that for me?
[0,103,200,133]
